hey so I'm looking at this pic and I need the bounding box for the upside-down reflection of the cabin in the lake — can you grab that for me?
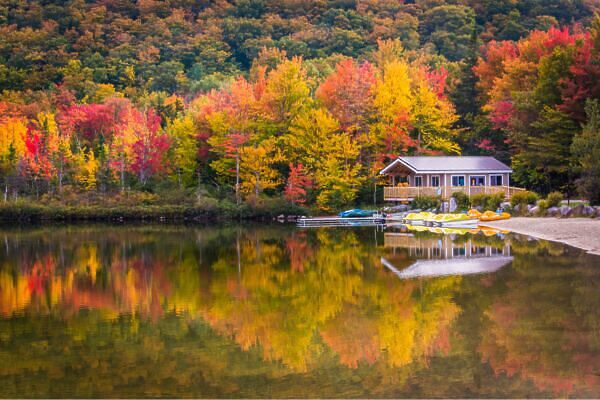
[381,232,513,279]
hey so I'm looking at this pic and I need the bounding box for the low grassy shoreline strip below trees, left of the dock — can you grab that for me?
[0,202,307,223]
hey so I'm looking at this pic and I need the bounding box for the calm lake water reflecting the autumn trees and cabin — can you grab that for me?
[0,225,600,397]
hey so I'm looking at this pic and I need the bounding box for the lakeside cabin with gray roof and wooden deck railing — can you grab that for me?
[379,156,524,202]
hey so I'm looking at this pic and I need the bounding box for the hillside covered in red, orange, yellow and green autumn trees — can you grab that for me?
[0,0,600,210]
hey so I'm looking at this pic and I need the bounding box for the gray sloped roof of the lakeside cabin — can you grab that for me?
[379,156,512,174]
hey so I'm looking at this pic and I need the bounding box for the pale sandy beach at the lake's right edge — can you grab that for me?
[485,217,600,255]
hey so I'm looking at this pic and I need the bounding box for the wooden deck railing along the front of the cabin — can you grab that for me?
[383,186,525,201]
